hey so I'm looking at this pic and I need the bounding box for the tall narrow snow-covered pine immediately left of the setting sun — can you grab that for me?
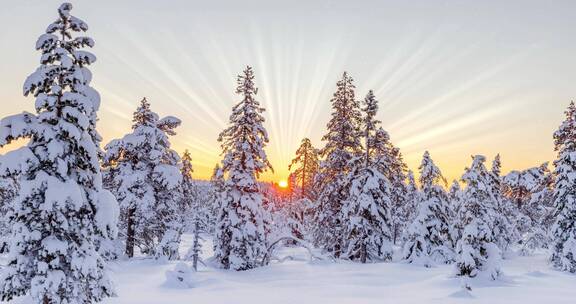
[215,66,272,270]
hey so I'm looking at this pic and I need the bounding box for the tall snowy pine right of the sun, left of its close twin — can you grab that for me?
[313,72,362,257]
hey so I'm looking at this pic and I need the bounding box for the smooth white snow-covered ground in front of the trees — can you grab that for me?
[6,235,576,304]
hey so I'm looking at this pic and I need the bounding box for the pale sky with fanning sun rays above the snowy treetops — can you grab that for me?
[0,0,576,181]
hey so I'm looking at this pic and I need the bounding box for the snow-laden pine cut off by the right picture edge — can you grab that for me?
[550,102,576,273]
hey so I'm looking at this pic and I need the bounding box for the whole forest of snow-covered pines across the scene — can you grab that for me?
[0,3,576,304]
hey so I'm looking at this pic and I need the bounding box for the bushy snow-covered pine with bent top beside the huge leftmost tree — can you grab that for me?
[103,98,182,259]
